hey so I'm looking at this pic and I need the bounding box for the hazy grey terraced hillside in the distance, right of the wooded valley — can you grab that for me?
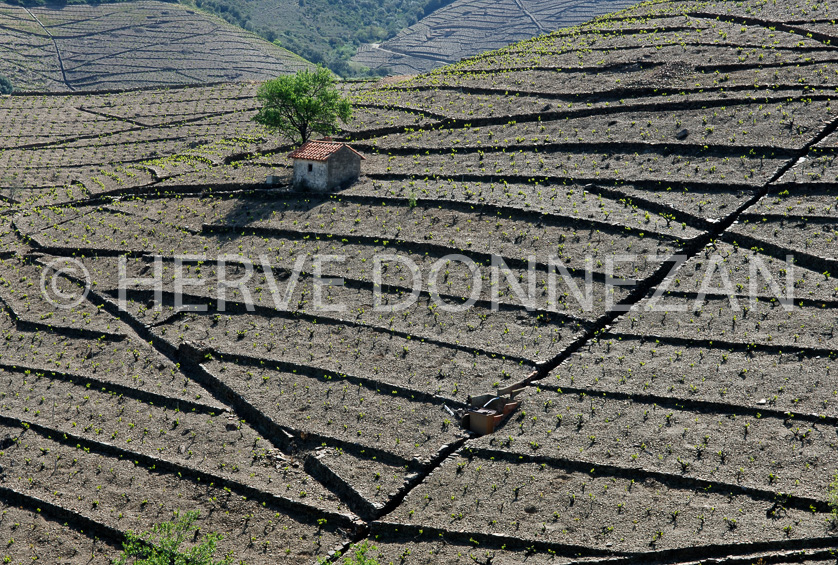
[352,0,637,74]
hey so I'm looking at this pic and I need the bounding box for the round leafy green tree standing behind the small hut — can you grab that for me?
[253,67,352,144]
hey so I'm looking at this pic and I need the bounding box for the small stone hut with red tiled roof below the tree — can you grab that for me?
[288,138,365,192]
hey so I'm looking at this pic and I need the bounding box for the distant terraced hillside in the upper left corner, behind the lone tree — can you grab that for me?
[0,1,310,91]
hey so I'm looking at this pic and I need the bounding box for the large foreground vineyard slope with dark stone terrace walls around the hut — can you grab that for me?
[0,1,838,565]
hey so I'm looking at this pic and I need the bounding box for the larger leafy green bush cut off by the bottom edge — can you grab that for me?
[115,511,233,565]
